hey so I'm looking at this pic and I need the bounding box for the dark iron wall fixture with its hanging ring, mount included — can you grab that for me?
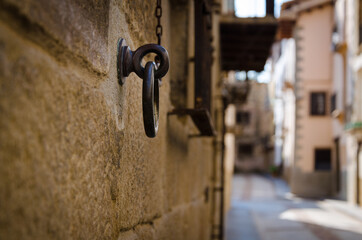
[117,38,170,138]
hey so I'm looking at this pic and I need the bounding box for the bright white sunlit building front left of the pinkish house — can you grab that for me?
[269,38,296,181]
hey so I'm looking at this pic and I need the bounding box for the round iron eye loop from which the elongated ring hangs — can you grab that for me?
[132,44,170,78]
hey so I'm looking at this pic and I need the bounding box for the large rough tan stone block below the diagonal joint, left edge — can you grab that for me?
[0,21,116,239]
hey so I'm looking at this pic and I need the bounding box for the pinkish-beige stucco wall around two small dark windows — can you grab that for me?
[291,5,334,197]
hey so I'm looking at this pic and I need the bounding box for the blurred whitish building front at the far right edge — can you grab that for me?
[333,0,362,205]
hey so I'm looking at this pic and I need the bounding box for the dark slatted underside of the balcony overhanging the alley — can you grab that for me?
[220,16,278,72]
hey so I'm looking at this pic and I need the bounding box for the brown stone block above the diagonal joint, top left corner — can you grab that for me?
[0,0,110,73]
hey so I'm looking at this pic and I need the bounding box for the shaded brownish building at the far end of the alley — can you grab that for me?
[234,80,273,172]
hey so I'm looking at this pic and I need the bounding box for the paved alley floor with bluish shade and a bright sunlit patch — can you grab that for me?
[226,174,362,240]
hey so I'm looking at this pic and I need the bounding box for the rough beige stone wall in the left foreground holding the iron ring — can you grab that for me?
[0,0,219,240]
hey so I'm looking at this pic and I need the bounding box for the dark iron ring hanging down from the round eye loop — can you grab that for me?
[142,62,160,138]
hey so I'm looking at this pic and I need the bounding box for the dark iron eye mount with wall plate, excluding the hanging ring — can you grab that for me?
[117,38,170,85]
